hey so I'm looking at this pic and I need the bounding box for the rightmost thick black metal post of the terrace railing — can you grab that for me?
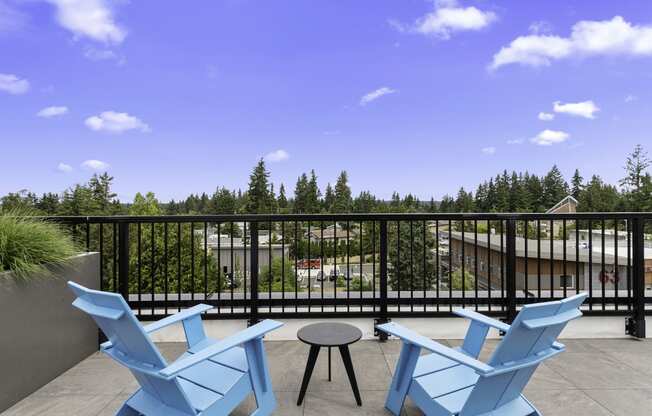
[625,217,645,338]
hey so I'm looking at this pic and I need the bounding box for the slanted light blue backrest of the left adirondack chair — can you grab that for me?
[68,282,196,415]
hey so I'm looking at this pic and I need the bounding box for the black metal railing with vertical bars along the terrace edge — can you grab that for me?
[50,213,652,337]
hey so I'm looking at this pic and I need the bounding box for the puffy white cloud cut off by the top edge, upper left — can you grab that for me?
[47,0,127,44]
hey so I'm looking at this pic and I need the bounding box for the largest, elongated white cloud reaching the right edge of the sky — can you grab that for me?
[489,16,652,70]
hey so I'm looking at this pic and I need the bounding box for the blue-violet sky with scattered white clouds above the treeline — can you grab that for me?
[0,0,652,200]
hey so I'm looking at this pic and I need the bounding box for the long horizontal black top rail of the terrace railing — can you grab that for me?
[43,212,652,224]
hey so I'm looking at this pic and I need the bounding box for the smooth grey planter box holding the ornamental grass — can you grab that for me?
[0,253,100,412]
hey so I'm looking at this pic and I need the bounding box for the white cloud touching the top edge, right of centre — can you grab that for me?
[390,1,498,39]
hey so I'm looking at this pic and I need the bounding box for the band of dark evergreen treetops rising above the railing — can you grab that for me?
[1,145,652,215]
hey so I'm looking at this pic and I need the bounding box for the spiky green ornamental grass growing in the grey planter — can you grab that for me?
[0,211,78,279]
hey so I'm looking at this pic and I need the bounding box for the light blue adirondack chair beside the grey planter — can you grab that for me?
[68,282,283,416]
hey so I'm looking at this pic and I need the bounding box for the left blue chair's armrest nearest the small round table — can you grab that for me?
[159,319,283,379]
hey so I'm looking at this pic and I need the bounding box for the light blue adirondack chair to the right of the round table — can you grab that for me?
[378,293,587,416]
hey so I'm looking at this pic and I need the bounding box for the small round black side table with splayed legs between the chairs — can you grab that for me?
[297,322,362,406]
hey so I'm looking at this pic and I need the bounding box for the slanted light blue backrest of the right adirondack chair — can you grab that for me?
[460,293,587,416]
